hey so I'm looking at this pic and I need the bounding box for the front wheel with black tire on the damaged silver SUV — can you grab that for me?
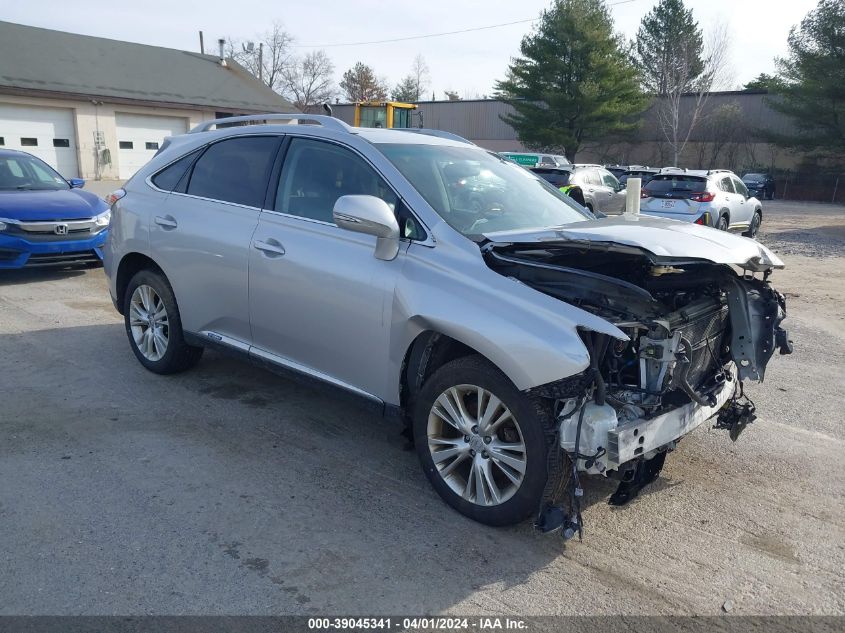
[413,356,555,526]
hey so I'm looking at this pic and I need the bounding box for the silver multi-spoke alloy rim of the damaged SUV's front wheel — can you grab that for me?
[427,385,527,507]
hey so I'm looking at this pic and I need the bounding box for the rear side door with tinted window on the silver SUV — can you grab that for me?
[150,136,280,344]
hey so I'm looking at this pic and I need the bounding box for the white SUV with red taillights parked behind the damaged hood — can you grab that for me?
[640,169,763,237]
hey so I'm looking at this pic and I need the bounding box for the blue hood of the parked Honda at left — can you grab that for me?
[0,189,109,222]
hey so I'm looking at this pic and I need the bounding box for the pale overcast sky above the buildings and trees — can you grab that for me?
[0,0,816,99]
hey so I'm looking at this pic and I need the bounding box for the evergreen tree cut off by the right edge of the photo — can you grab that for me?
[769,0,845,159]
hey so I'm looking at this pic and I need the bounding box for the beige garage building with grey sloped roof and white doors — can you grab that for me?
[0,22,296,179]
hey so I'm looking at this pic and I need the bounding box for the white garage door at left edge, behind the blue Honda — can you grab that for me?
[0,103,79,178]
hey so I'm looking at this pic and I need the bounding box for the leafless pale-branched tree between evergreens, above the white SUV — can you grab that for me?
[654,23,732,165]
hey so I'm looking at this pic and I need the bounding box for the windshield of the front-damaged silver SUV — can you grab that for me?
[376,143,594,237]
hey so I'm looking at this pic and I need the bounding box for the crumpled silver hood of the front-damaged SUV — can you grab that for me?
[484,214,784,271]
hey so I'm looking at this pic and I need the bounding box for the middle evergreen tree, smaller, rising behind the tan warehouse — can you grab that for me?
[634,0,705,96]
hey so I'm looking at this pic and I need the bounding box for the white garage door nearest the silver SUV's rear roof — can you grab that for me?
[115,112,187,178]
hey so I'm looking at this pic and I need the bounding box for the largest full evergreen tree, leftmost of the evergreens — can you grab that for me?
[496,0,646,160]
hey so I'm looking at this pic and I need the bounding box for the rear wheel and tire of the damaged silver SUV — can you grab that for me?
[123,270,203,374]
